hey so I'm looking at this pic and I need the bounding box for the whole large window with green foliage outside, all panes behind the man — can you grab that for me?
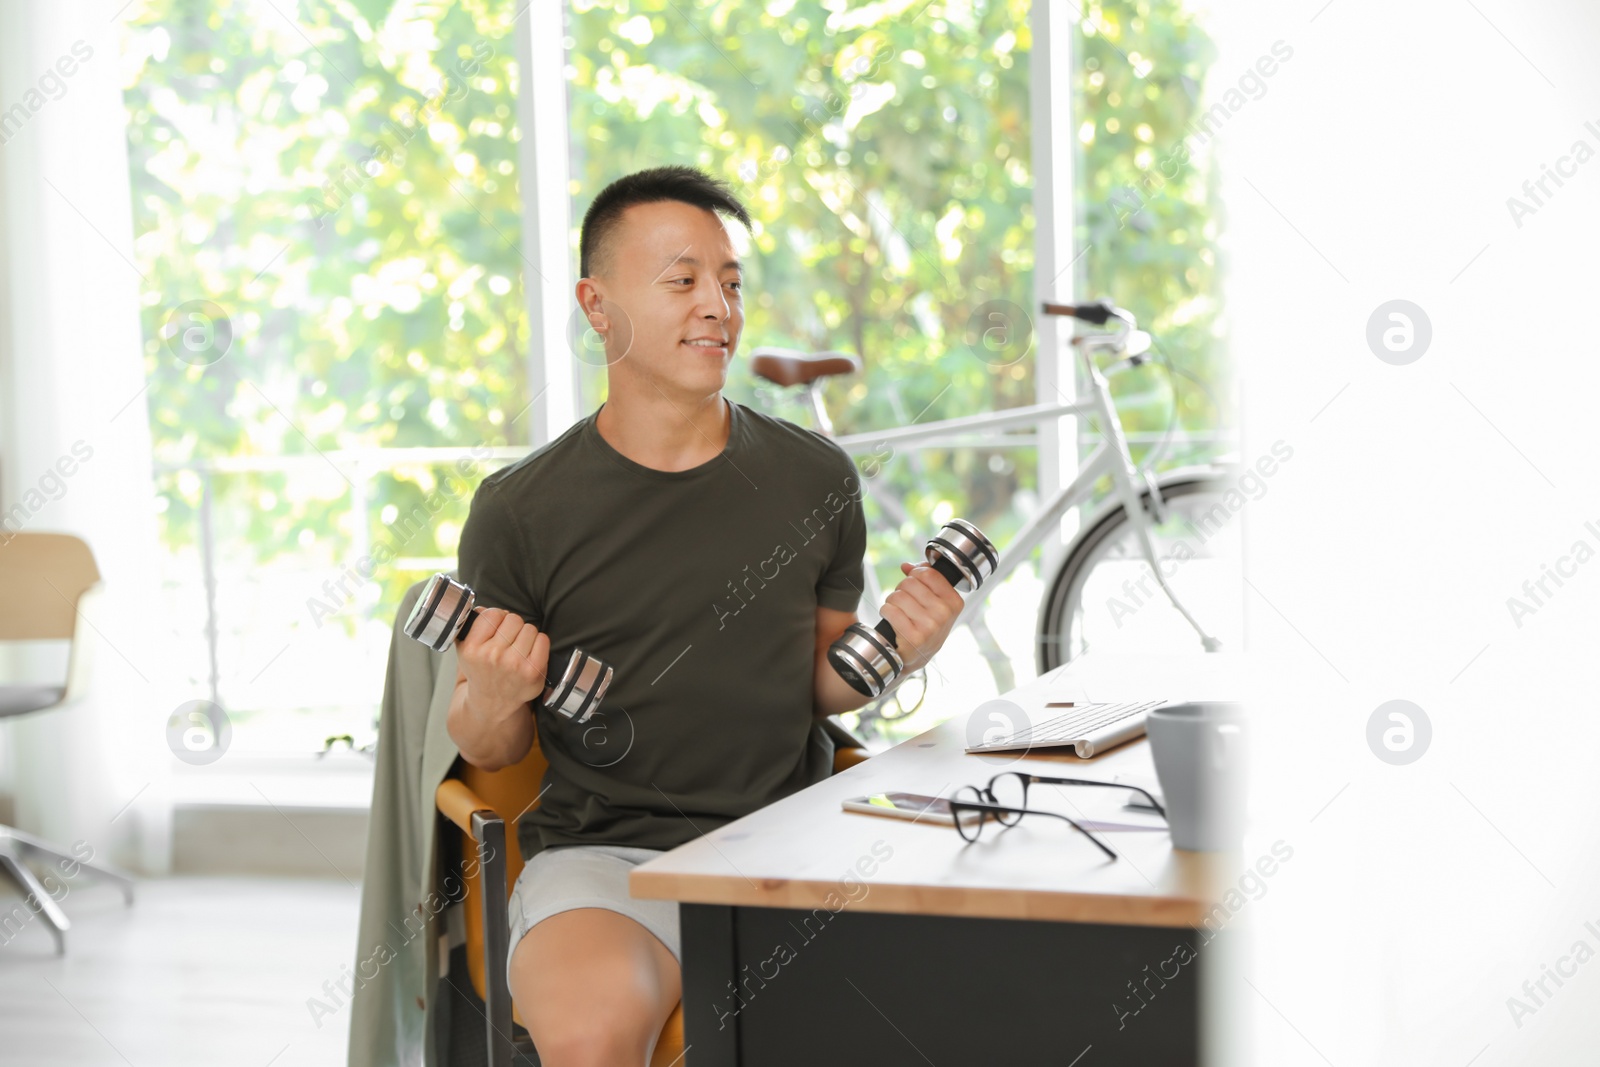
[125,0,1224,764]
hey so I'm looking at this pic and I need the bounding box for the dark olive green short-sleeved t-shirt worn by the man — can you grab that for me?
[459,402,866,859]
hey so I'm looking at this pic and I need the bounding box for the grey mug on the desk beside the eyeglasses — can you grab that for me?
[1144,702,1245,853]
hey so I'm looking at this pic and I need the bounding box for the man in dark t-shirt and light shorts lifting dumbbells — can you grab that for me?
[450,166,962,1067]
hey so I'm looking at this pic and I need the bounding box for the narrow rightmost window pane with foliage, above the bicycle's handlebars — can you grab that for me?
[1072,0,1234,467]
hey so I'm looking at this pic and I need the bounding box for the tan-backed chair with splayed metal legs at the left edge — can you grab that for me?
[0,533,133,955]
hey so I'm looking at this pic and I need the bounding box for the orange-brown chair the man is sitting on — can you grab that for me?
[435,681,867,1067]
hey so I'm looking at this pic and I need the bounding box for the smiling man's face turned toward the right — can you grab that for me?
[578,200,744,402]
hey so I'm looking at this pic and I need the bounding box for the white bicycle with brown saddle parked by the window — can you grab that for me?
[750,301,1243,729]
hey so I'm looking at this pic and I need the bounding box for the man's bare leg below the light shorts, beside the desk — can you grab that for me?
[510,907,683,1067]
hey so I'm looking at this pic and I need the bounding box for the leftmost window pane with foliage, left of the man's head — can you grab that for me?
[126,0,530,750]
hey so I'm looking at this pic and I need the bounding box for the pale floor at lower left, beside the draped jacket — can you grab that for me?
[0,877,360,1067]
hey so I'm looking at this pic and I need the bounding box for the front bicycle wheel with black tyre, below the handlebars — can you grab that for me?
[1038,472,1246,673]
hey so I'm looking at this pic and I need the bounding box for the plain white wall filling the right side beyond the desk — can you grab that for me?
[1211,0,1600,1067]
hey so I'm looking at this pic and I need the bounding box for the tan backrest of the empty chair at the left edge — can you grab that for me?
[0,533,99,641]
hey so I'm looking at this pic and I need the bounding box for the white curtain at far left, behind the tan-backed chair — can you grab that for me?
[0,0,178,872]
